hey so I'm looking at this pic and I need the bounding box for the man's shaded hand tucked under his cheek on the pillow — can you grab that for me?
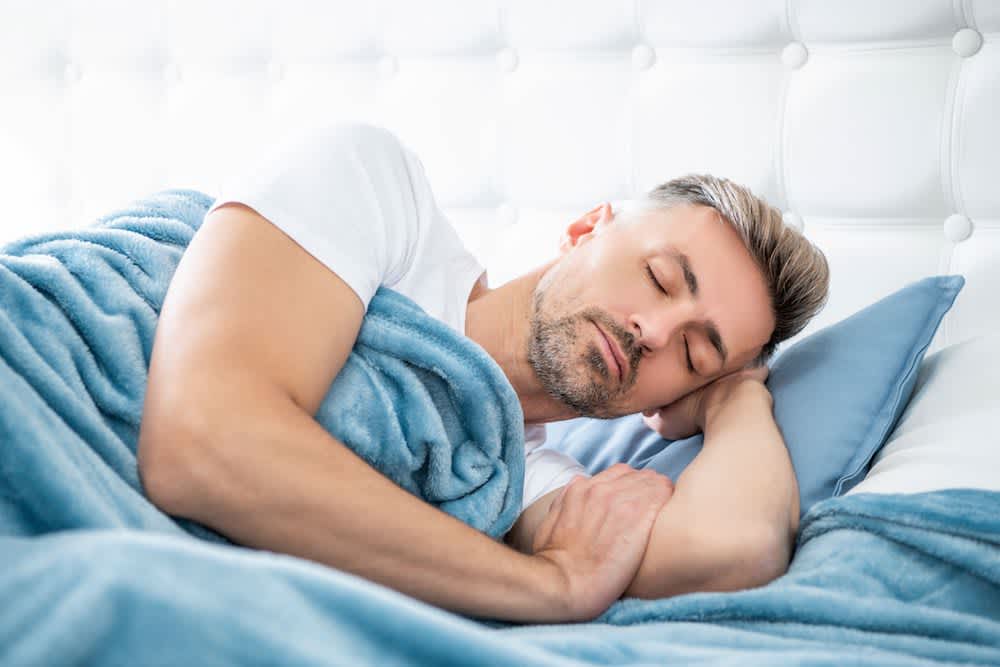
[642,365,769,440]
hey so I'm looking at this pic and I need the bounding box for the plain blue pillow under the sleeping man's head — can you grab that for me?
[544,275,965,515]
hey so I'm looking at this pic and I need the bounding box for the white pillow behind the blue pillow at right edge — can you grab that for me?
[845,333,1000,495]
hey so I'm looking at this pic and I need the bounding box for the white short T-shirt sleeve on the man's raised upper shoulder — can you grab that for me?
[206,123,425,309]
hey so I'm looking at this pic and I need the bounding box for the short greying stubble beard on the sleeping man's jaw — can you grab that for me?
[528,281,641,419]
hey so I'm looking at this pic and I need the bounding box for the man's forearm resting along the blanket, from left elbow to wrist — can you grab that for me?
[143,392,565,622]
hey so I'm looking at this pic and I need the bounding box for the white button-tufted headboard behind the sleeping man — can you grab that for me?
[0,0,1000,349]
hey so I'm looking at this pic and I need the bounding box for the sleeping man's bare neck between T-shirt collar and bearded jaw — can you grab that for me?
[465,265,579,424]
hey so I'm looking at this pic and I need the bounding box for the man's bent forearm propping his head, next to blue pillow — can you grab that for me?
[625,384,799,598]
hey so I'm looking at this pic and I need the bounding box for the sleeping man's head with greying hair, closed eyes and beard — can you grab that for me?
[528,176,829,417]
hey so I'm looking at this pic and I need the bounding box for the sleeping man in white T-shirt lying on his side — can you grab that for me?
[139,124,828,622]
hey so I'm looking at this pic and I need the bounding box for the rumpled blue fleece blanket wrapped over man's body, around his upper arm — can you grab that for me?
[0,190,524,542]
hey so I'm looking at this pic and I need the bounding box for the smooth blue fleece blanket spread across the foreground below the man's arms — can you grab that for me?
[0,490,1000,667]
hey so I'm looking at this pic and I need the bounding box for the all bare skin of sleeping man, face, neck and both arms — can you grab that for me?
[137,194,798,622]
